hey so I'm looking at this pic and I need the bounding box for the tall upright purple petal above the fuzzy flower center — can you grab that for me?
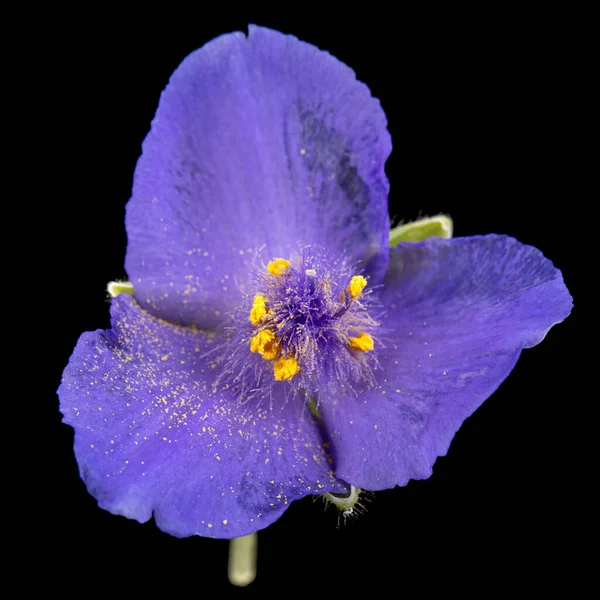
[126,27,391,328]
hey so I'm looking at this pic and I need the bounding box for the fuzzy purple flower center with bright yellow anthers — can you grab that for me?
[220,247,378,398]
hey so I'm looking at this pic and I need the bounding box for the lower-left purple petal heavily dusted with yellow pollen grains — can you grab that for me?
[59,294,347,538]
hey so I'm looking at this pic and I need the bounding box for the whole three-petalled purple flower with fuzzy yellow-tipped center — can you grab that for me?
[59,27,571,538]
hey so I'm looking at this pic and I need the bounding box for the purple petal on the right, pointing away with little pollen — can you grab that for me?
[319,235,572,490]
